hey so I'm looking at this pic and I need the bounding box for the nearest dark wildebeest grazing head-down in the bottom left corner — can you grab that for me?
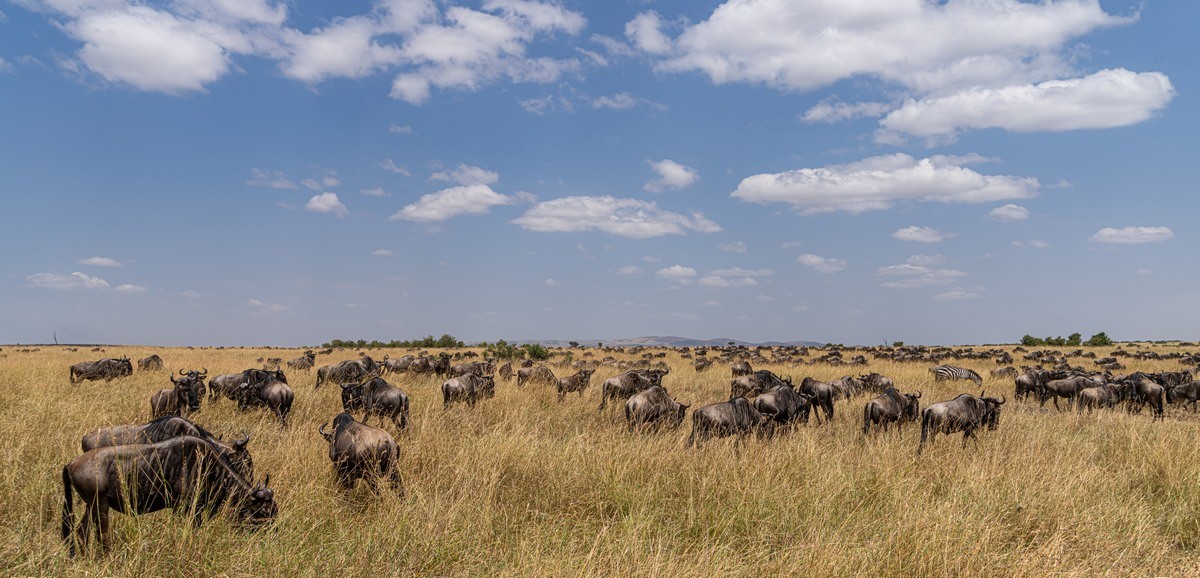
[61,435,277,556]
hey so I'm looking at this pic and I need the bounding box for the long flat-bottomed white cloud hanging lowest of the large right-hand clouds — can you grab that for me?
[732,152,1040,213]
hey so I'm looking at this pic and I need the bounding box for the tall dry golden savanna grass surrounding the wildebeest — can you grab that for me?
[7,347,1200,577]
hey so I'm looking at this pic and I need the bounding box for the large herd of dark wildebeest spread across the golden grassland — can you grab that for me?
[51,350,1200,553]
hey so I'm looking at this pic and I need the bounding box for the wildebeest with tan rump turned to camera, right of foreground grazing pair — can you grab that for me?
[317,413,404,496]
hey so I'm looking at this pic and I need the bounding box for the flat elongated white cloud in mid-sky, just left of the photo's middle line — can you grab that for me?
[512,195,721,239]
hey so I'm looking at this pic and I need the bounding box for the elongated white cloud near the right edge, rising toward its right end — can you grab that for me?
[880,68,1175,140]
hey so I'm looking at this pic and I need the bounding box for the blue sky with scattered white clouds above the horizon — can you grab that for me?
[0,0,1200,345]
